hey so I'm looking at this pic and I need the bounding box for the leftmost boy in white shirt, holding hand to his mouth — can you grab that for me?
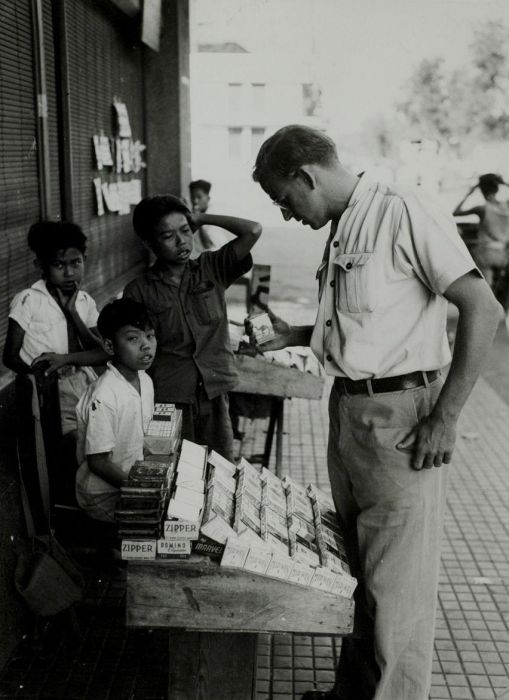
[3,221,106,435]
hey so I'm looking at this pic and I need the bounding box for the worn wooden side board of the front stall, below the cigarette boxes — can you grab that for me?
[126,558,354,635]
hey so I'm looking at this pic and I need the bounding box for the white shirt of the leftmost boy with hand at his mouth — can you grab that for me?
[9,280,98,365]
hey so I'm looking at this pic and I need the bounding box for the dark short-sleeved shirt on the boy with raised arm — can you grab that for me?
[124,243,252,403]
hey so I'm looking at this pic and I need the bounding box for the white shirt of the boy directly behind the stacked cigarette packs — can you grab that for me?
[76,362,154,507]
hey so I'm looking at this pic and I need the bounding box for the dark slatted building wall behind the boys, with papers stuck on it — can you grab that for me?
[0,0,190,668]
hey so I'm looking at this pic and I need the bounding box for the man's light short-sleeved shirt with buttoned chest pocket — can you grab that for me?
[311,175,476,379]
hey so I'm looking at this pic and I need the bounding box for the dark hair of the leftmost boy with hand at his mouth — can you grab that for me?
[27,221,87,264]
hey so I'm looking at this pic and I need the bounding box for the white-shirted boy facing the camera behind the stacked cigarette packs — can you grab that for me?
[76,299,157,521]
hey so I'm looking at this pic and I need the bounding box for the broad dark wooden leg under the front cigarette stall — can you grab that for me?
[168,630,257,700]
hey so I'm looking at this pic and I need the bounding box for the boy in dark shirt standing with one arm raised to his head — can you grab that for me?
[124,195,262,460]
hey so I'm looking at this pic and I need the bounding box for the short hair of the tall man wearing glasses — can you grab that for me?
[253,124,338,187]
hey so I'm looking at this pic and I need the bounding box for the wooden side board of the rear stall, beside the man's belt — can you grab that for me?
[235,355,325,399]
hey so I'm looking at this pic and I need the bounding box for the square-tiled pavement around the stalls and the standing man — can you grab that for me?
[0,366,509,700]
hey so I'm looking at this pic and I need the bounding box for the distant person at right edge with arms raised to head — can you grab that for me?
[453,173,509,294]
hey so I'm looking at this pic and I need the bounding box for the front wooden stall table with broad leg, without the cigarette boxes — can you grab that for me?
[126,555,354,700]
